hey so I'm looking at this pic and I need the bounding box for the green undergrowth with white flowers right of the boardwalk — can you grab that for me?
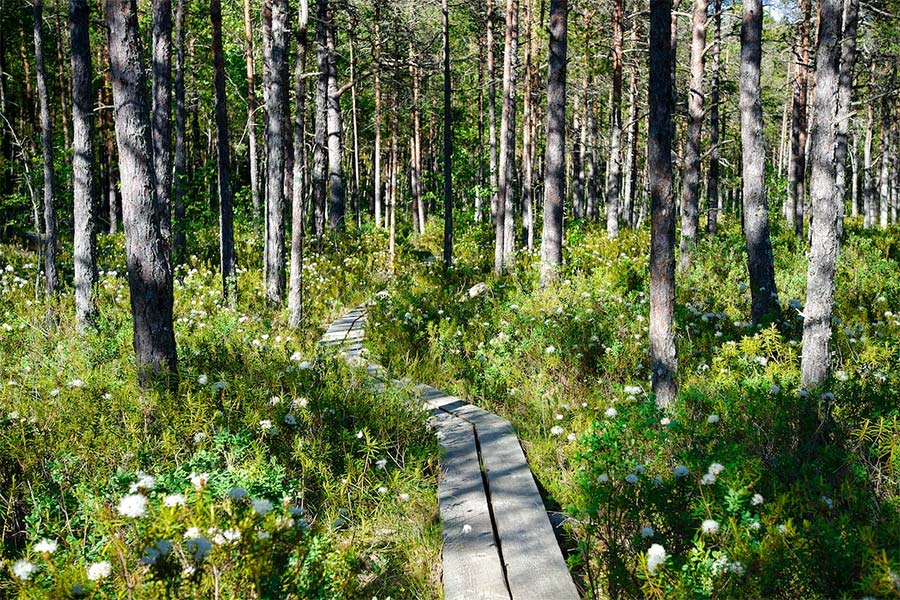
[367,220,900,598]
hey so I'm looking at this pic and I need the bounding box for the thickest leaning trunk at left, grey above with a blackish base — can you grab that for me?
[106,0,177,387]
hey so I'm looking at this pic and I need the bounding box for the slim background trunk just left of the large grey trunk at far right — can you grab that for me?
[788,0,810,237]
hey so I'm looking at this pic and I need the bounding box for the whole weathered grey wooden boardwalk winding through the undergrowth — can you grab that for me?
[321,306,580,600]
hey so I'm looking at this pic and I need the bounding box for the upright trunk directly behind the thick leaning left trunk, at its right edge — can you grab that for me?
[153,0,172,254]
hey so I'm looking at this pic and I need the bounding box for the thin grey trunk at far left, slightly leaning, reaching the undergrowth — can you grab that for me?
[33,0,59,294]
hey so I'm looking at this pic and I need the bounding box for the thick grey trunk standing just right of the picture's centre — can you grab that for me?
[541,0,569,286]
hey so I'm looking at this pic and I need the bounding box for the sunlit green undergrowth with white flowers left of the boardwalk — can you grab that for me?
[0,229,440,599]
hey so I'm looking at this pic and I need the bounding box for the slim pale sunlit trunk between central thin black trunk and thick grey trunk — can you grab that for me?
[494,0,519,273]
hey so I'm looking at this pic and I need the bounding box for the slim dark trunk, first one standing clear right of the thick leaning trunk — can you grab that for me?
[209,0,237,298]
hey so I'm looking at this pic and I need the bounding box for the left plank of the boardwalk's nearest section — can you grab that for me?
[432,413,510,600]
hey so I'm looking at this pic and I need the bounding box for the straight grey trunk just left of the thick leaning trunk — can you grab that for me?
[69,0,97,332]
